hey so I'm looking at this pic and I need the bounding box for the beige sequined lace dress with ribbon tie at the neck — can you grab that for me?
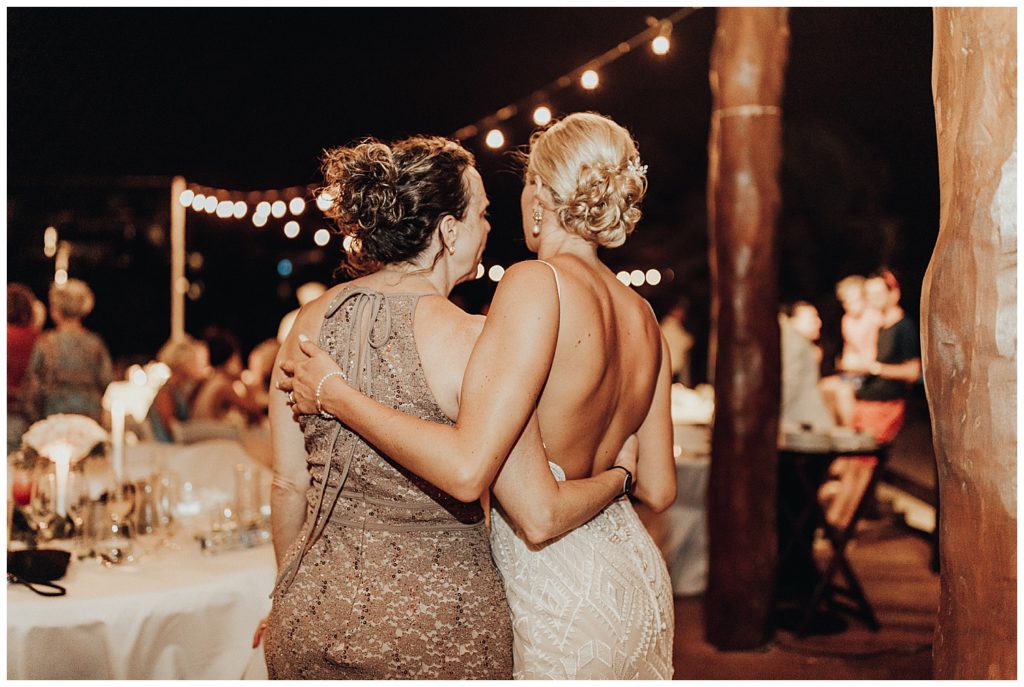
[264,287,512,679]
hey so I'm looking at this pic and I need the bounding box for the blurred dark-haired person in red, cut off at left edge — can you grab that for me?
[7,284,41,453]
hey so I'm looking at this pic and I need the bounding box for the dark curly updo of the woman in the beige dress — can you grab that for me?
[322,136,476,276]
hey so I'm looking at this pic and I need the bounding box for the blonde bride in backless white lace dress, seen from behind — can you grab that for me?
[280,113,676,679]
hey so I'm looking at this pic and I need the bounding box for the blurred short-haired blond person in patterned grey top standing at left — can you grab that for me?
[26,280,114,422]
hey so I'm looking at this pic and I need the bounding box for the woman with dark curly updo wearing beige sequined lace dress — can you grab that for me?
[264,136,630,679]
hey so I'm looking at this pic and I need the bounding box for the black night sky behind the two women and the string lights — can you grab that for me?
[7,7,938,379]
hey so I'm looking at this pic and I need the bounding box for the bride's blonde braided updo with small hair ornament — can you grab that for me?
[525,113,647,248]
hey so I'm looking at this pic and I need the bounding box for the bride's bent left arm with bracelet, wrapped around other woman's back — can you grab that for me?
[283,262,561,502]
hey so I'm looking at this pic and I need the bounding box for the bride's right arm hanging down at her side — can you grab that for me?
[633,337,676,513]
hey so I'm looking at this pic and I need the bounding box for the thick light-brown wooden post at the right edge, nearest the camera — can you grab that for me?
[921,7,1017,680]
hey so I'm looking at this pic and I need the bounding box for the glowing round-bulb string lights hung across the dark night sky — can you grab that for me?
[159,7,699,287]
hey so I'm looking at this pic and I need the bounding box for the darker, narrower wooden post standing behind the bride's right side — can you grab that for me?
[705,7,790,650]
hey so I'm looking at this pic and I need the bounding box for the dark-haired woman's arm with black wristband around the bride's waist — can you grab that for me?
[494,414,637,544]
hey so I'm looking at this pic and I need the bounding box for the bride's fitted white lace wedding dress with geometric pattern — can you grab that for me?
[490,463,675,680]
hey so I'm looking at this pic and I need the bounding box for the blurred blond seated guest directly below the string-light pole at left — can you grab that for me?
[150,335,208,442]
